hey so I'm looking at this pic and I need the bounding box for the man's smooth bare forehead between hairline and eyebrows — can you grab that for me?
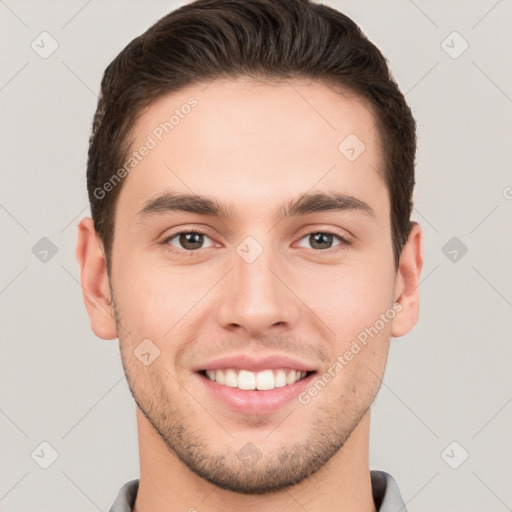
[119,78,387,221]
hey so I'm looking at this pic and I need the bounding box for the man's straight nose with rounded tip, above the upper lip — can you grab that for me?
[217,239,302,337]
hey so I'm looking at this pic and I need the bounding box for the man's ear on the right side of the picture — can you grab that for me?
[391,222,423,337]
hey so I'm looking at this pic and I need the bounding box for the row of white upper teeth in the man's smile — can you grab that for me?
[206,368,306,391]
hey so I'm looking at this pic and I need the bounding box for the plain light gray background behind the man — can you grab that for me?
[0,0,512,512]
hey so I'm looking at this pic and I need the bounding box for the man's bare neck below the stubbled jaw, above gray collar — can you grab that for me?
[134,408,376,512]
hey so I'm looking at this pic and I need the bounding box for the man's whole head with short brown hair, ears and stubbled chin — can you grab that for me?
[77,0,422,493]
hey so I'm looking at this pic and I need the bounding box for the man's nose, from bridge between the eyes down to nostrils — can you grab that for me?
[218,235,299,335]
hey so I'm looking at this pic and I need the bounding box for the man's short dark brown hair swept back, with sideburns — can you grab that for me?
[87,0,416,270]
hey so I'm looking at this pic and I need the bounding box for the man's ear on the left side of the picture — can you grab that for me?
[76,217,117,340]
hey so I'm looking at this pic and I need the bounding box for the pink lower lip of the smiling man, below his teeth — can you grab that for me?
[196,373,316,415]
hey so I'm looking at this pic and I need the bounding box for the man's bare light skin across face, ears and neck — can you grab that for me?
[77,79,423,512]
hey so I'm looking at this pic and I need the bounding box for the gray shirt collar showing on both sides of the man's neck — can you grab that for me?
[110,470,407,512]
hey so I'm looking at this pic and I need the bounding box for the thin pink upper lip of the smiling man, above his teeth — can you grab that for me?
[193,354,316,372]
